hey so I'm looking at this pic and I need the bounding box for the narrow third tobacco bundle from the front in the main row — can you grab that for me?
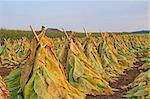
[83,33,109,81]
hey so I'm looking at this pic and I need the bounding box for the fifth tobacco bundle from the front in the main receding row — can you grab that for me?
[112,33,137,70]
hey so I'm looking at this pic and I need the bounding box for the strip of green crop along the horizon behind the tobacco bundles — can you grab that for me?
[0,29,133,40]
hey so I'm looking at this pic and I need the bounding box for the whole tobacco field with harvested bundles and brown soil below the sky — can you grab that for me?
[0,29,150,99]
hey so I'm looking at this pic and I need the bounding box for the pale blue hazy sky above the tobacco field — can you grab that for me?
[0,0,150,32]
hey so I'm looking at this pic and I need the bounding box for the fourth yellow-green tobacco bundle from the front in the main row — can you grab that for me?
[98,33,124,82]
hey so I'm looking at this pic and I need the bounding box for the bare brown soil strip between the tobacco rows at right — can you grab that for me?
[87,61,143,99]
